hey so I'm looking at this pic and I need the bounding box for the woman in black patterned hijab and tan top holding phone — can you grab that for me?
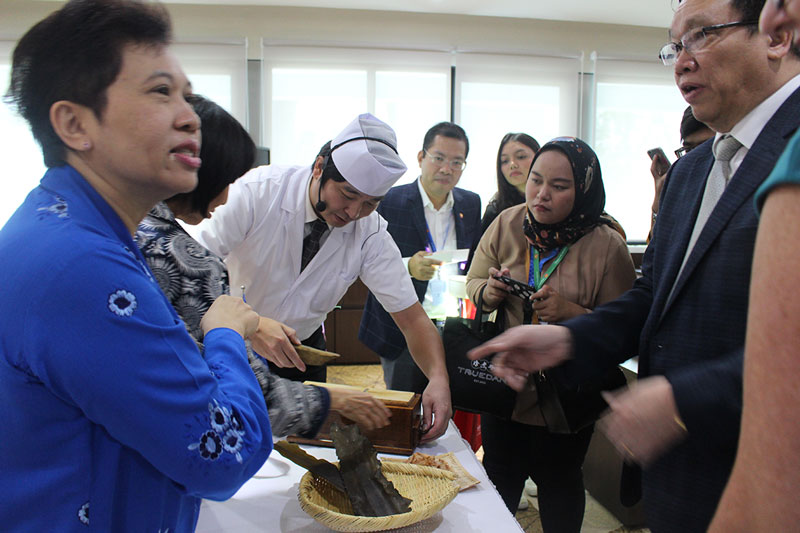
[467,137,635,533]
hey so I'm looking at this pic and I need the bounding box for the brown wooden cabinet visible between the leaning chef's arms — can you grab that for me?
[325,279,381,365]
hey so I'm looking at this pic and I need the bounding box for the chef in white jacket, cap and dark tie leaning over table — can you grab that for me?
[197,114,452,440]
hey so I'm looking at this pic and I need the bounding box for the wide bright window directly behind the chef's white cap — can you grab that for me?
[263,45,450,177]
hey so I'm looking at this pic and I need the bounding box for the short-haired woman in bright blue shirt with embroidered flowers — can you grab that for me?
[0,0,272,532]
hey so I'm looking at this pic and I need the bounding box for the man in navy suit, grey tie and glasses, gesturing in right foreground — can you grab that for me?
[473,0,800,533]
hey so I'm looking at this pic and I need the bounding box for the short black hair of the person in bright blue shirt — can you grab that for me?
[5,0,172,167]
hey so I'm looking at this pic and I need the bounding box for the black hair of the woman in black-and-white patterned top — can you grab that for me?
[169,94,256,216]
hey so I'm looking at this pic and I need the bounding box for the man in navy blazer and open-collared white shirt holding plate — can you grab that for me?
[358,122,481,392]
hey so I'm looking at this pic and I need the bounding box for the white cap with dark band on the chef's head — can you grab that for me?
[331,113,407,196]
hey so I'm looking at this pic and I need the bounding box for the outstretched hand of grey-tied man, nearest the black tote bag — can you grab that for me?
[467,325,572,391]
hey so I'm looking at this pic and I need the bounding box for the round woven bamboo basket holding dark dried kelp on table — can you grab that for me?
[298,462,458,531]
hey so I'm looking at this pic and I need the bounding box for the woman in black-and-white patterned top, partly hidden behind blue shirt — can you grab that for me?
[135,95,389,438]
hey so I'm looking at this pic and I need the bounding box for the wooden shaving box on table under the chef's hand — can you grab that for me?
[288,381,422,455]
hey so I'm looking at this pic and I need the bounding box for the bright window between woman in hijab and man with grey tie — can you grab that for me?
[594,62,686,242]
